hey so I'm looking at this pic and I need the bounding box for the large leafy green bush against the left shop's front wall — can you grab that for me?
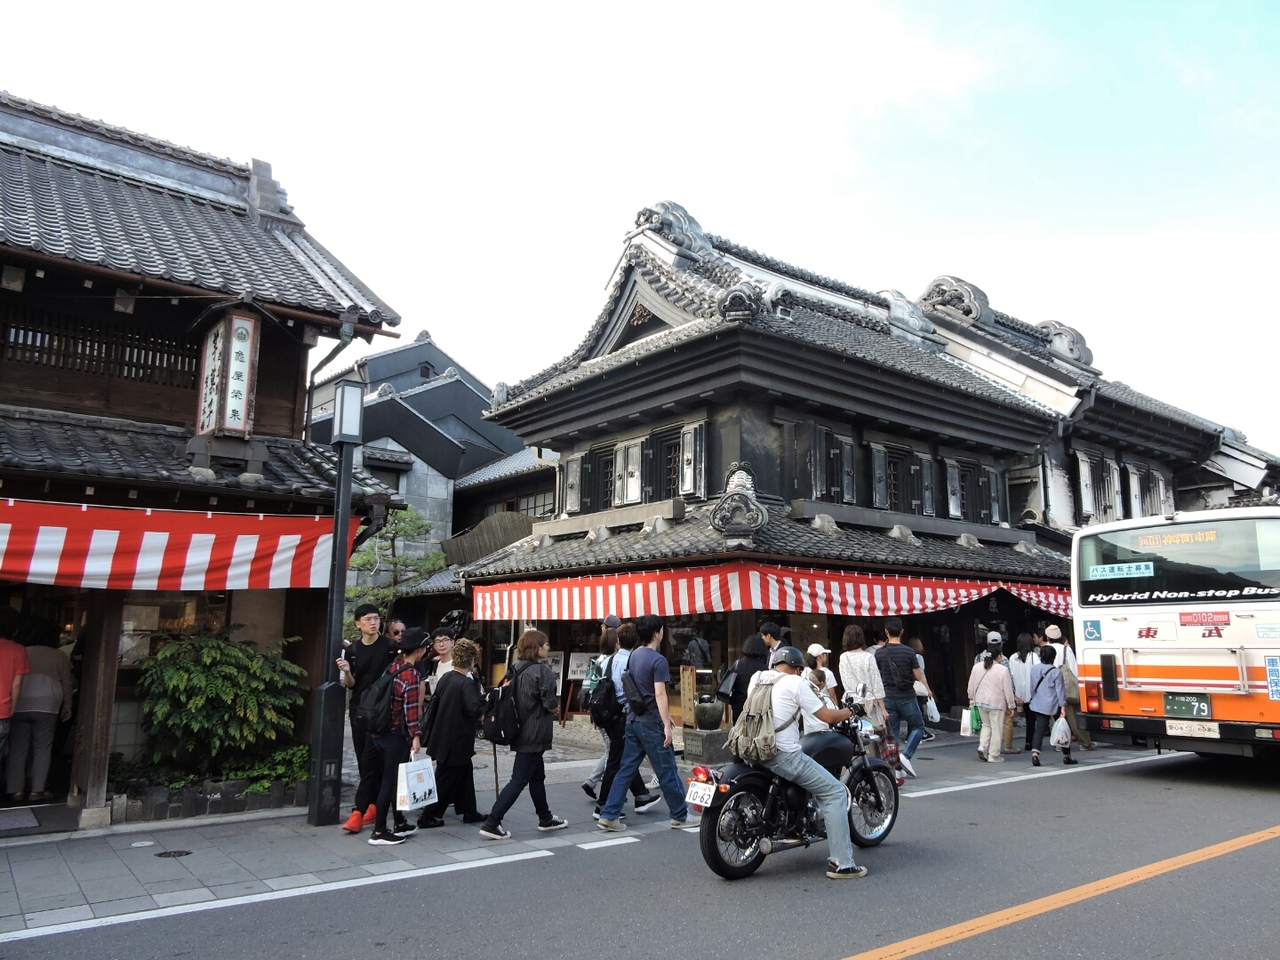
[141,625,306,773]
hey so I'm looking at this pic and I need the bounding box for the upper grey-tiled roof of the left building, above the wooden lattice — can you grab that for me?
[0,93,399,324]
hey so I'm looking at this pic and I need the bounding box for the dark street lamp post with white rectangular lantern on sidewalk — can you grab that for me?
[307,380,365,827]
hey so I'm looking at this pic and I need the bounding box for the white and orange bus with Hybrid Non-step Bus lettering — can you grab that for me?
[1071,506,1280,756]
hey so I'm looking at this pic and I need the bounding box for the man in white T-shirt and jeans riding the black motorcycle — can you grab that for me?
[750,646,867,879]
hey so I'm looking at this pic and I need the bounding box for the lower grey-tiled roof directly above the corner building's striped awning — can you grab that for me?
[465,503,1070,581]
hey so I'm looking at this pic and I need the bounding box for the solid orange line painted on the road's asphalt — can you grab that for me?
[845,826,1280,960]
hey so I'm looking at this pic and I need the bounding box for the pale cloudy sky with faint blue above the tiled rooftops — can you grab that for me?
[0,0,1280,453]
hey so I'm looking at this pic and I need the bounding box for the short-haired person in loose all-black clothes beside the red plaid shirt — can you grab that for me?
[417,640,484,828]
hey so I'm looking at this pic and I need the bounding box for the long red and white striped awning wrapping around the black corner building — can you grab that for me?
[472,561,1071,620]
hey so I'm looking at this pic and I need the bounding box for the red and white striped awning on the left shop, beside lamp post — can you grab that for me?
[0,499,360,590]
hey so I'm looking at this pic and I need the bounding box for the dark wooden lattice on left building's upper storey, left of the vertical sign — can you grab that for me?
[4,306,200,390]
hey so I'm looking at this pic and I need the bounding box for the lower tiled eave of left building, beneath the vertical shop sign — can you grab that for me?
[0,406,403,504]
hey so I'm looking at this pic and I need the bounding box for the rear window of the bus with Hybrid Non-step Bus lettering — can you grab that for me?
[1076,517,1280,607]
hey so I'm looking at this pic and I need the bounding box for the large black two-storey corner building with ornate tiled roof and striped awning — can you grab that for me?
[460,204,1280,709]
